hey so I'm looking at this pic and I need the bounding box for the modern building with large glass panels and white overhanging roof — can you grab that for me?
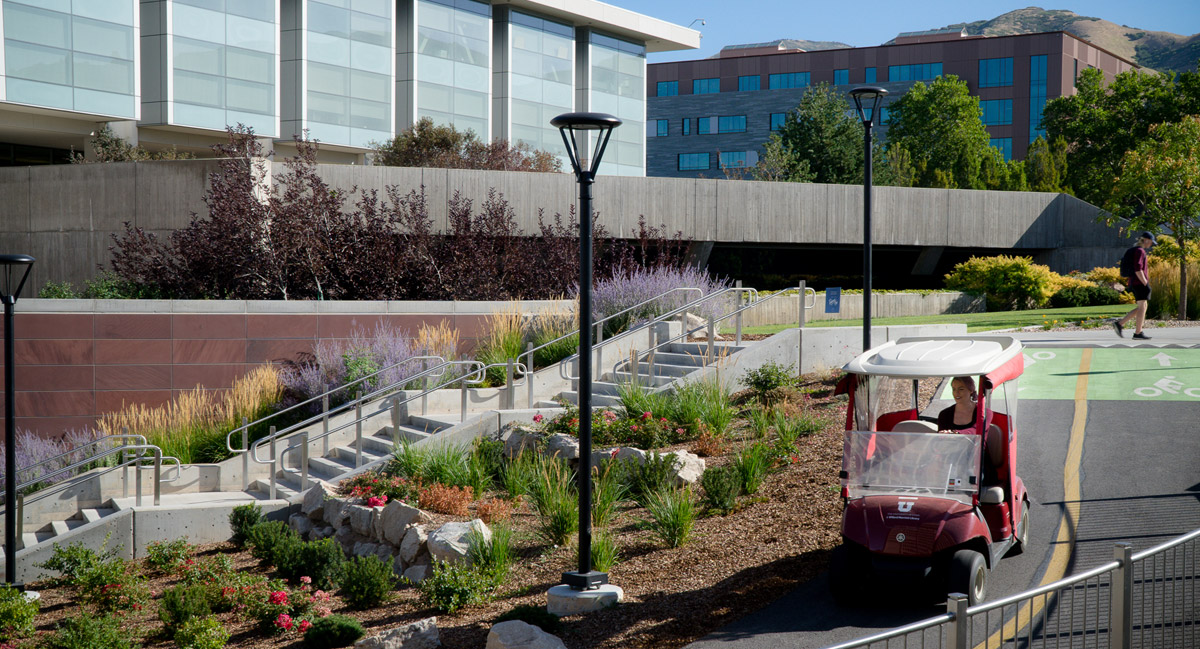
[0,0,700,170]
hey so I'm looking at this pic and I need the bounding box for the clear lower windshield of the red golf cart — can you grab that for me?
[841,431,979,503]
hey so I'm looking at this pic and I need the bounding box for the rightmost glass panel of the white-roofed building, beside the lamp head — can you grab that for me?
[589,32,646,176]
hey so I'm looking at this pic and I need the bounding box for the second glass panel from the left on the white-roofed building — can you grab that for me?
[168,0,280,137]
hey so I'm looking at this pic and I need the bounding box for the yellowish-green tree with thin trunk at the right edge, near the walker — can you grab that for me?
[1109,115,1200,319]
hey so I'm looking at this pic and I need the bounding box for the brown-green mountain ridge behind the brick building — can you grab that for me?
[942,7,1200,72]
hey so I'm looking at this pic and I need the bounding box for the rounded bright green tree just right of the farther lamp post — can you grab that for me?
[888,74,1007,190]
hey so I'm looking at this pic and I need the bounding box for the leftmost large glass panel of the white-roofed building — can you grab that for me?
[2,0,139,119]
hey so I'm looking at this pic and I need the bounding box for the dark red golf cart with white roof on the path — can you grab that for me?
[829,336,1030,605]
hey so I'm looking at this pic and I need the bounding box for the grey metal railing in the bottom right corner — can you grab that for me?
[827,529,1200,649]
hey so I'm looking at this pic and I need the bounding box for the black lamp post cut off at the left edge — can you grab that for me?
[0,254,34,587]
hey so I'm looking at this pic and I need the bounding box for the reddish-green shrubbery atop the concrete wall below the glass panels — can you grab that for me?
[371,118,563,172]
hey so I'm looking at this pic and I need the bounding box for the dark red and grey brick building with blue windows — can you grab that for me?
[646,30,1138,178]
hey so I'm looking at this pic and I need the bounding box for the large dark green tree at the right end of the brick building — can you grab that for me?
[1042,68,1200,205]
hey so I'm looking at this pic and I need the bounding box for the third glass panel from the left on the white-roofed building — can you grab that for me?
[305,0,395,148]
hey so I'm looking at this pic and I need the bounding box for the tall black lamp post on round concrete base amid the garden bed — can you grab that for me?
[550,113,620,590]
